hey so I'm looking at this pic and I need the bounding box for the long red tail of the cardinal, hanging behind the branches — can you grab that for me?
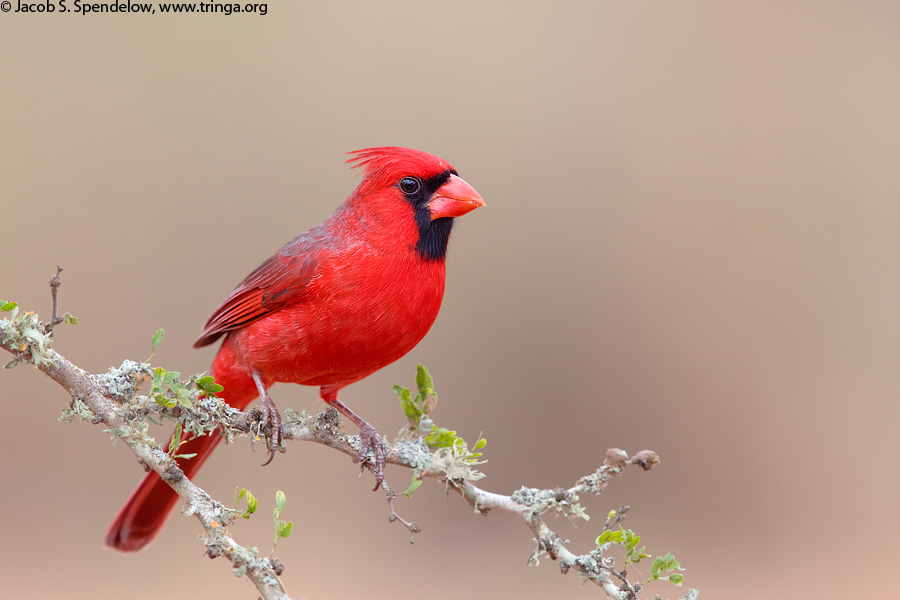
[105,340,257,552]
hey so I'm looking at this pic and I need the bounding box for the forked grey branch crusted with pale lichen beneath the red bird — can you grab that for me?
[0,277,693,600]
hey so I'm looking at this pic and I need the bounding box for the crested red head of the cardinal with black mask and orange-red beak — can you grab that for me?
[347,147,484,260]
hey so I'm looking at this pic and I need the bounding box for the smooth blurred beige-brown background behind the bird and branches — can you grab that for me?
[0,1,900,600]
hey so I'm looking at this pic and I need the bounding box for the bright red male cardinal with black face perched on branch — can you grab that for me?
[106,148,484,552]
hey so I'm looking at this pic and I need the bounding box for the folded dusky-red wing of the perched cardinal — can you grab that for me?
[194,228,329,348]
